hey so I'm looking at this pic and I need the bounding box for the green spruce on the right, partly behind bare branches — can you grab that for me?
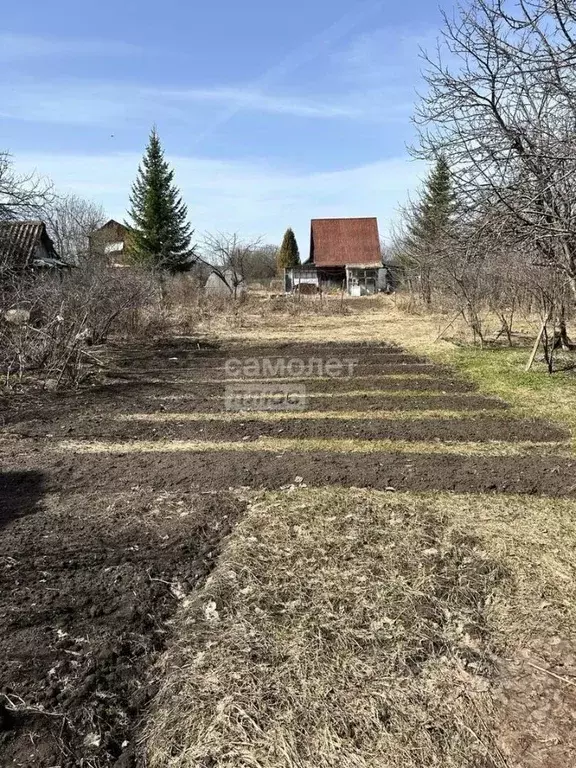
[404,155,455,304]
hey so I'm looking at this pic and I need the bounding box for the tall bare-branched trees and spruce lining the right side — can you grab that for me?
[394,0,576,354]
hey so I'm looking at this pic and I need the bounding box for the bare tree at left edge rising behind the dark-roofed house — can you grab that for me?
[0,151,53,221]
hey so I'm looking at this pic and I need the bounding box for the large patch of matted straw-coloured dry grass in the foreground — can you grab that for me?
[148,489,576,768]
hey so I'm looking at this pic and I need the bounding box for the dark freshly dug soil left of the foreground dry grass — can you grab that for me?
[0,486,242,768]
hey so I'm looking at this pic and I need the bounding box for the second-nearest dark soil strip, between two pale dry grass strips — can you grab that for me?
[82,420,569,442]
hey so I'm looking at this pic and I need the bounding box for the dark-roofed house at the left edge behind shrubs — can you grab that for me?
[0,221,70,274]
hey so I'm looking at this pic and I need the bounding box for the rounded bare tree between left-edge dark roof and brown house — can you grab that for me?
[45,195,106,264]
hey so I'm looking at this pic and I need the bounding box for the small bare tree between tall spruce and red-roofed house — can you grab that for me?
[199,232,262,299]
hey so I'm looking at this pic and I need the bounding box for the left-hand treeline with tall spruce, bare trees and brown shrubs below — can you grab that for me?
[0,129,300,389]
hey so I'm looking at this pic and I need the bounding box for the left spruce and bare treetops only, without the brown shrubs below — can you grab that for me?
[0,128,300,284]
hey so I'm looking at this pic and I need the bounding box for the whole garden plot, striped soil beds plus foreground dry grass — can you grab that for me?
[0,339,576,768]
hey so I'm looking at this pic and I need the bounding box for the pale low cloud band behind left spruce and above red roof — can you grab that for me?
[16,153,424,245]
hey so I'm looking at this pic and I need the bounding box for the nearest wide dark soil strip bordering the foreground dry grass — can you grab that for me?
[11,451,576,498]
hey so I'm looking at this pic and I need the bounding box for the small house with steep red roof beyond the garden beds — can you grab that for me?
[285,218,387,296]
